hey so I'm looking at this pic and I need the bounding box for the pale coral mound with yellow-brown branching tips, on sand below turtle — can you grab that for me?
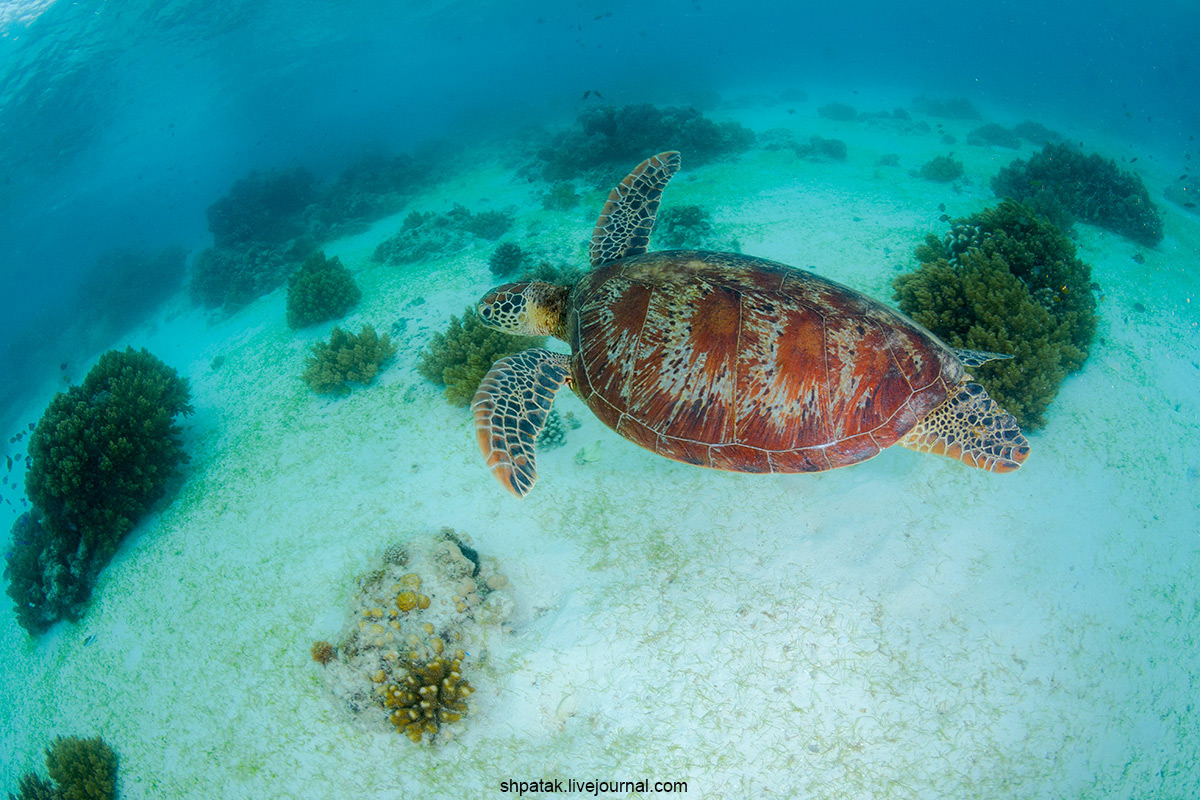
[311,528,515,745]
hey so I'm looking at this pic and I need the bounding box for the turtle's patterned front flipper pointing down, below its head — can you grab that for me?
[470,348,570,498]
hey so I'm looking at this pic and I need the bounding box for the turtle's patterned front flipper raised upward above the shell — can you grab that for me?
[589,150,679,266]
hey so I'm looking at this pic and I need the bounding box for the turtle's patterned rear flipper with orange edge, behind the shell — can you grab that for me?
[900,381,1030,473]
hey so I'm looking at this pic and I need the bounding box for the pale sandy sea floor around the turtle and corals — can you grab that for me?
[0,90,1200,800]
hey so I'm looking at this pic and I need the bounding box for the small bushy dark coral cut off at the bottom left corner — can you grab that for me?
[8,736,118,800]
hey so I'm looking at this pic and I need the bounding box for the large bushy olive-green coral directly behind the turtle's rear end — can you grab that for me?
[893,200,1097,428]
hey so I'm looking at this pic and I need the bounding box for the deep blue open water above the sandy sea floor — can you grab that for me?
[0,0,1200,429]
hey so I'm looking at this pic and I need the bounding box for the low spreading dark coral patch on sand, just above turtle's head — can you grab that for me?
[372,203,512,264]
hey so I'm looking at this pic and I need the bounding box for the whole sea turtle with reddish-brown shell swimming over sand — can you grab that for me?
[472,151,1030,497]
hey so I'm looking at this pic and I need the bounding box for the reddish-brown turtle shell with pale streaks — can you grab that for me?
[566,251,964,473]
